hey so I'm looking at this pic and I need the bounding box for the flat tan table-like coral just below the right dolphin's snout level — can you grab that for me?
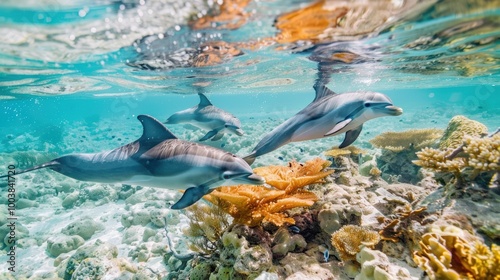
[370,128,442,152]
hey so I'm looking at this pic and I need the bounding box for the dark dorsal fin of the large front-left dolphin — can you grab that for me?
[137,115,177,145]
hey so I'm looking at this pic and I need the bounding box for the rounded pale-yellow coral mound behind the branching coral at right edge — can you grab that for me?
[439,115,488,150]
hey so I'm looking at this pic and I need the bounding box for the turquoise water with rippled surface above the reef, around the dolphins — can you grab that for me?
[0,0,500,274]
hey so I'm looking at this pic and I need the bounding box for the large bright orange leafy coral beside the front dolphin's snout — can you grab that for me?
[204,158,333,227]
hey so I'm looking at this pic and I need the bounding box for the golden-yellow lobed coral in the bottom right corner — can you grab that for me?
[413,226,500,280]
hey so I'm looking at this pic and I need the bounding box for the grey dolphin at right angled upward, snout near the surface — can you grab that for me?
[243,85,403,164]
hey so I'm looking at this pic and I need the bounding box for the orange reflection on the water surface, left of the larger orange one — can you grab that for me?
[189,0,251,30]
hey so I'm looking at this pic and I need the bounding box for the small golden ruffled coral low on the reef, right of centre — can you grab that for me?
[331,225,380,261]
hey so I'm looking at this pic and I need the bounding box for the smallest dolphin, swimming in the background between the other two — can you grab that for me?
[164,93,244,141]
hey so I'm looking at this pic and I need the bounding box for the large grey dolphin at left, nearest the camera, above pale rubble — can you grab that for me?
[0,115,265,209]
